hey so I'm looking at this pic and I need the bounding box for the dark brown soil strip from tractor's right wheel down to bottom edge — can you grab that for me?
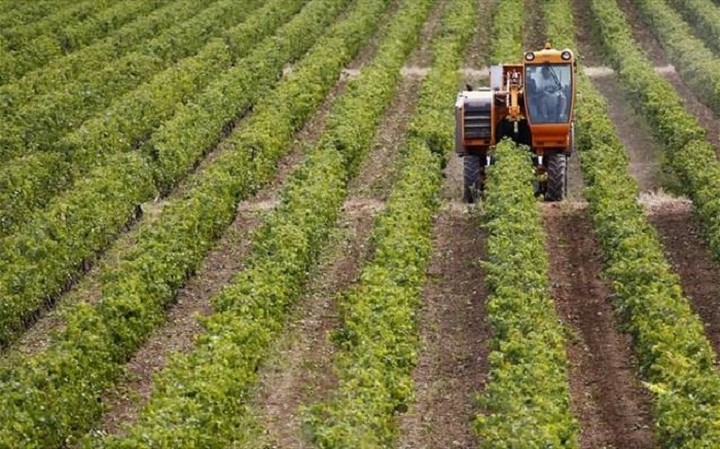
[543,204,653,449]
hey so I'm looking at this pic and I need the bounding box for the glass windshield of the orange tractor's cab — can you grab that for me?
[525,64,572,123]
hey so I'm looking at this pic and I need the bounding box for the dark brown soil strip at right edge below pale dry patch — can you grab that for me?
[647,203,720,354]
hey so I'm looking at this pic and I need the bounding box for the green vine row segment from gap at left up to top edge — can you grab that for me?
[143,0,347,192]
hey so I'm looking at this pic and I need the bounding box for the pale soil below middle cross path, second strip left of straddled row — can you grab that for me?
[254,209,374,449]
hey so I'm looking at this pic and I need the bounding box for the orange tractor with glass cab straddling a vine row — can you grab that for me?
[455,44,577,202]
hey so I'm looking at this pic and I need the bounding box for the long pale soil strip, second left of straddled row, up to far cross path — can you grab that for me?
[255,70,420,449]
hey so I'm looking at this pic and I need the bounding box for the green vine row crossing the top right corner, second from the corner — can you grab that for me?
[633,0,720,115]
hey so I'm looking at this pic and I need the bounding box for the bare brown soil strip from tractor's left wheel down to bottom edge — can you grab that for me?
[397,193,489,449]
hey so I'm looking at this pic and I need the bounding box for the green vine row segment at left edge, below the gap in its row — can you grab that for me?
[0,153,154,346]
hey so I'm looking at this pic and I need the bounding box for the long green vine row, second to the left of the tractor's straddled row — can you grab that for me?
[95,0,432,440]
